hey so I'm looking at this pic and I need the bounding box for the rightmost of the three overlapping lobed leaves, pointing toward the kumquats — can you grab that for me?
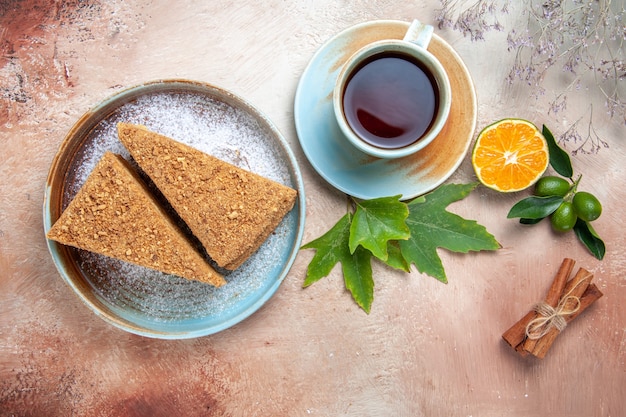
[399,183,500,282]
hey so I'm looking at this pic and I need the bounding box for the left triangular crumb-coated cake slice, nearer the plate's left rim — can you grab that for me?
[47,152,226,287]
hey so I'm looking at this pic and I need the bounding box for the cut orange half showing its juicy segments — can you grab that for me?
[472,119,550,192]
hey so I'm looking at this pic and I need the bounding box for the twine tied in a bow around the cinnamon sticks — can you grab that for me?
[526,277,586,340]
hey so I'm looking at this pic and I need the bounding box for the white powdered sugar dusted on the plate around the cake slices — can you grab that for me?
[54,83,304,337]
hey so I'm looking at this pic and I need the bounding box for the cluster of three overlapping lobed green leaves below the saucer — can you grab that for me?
[302,183,500,313]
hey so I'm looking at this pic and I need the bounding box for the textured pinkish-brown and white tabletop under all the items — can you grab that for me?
[0,0,626,417]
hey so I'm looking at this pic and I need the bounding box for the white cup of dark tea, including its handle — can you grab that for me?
[333,20,452,158]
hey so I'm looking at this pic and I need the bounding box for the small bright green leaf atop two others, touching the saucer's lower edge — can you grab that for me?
[350,195,410,261]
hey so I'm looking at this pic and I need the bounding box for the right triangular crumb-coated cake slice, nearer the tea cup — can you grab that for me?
[118,123,297,270]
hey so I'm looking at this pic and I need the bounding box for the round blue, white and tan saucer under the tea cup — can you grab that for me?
[294,20,477,200]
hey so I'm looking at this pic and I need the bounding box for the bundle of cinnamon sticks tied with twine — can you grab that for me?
[502,258,603,358]
